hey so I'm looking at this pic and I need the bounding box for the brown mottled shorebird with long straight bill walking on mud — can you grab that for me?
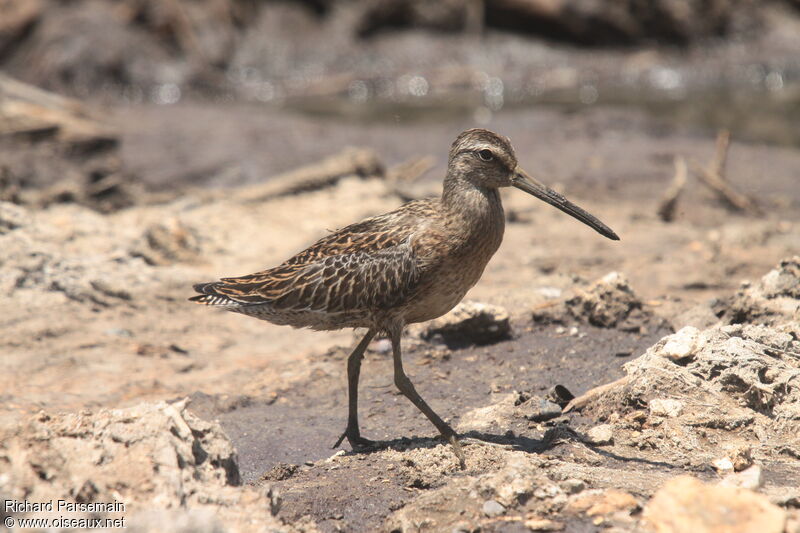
[190,129,619,467]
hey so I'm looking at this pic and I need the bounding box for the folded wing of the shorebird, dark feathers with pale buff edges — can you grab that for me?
[193,203,434,313]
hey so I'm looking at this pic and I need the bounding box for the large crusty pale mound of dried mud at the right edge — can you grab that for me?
[560,316,800,486]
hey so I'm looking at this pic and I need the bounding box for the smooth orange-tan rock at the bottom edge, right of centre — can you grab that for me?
[643,476,786,533]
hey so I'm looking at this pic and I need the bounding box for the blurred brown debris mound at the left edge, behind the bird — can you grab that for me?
[0,75,141,212]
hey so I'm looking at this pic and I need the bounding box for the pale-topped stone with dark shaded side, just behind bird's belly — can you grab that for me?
[416,301,511,348]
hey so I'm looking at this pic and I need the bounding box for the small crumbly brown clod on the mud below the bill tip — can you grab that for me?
[533,272,665,332]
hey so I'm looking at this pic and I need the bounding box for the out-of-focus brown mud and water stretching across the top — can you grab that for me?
[0,0,800,209]
